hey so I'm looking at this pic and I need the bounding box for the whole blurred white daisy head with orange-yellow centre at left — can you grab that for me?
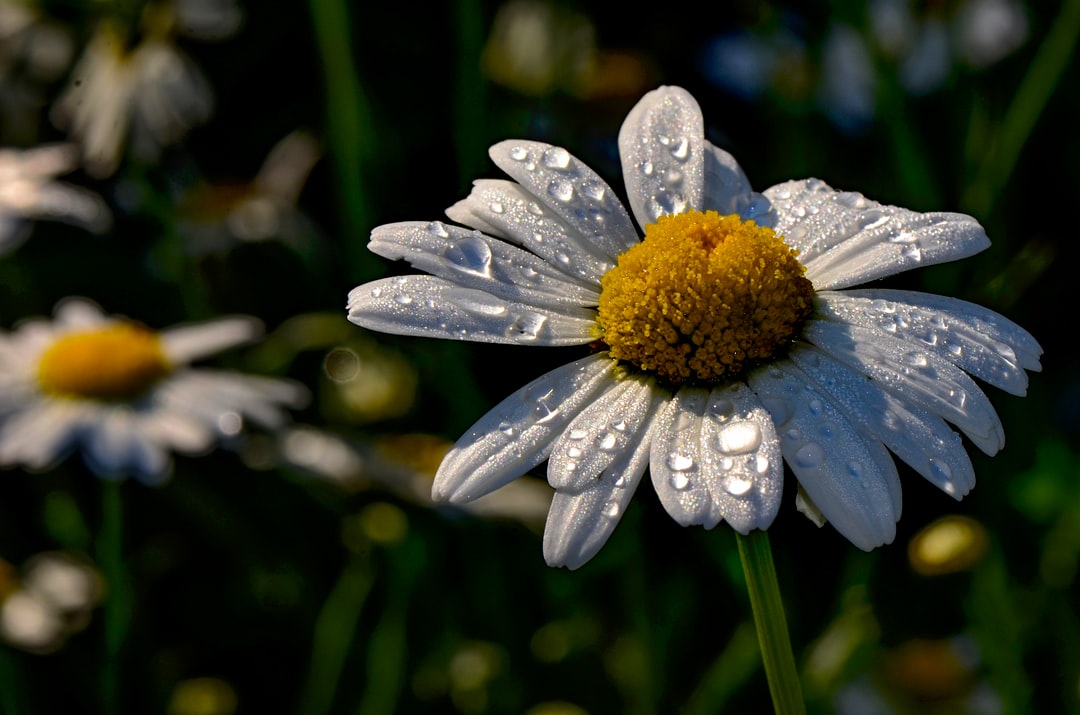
[0,299,306,484]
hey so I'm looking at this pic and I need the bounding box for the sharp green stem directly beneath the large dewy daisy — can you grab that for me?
[735,529,806,715]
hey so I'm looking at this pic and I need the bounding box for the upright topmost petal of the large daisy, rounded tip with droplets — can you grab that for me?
[619,86,705,229]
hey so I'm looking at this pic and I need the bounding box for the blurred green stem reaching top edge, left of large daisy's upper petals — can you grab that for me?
[308,0,378,281]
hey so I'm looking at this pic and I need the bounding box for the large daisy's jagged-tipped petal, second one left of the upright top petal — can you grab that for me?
[446,179,617,286]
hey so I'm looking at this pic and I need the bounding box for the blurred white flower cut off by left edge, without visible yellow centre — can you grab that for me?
[0,144,112,254]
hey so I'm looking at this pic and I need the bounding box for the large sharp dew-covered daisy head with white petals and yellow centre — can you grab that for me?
[349,87,1041,568]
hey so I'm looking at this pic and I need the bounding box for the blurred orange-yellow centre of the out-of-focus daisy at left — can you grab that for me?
[38,323,172,401]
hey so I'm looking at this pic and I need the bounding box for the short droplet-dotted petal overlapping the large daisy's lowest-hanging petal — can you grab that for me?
[548,375,663,491]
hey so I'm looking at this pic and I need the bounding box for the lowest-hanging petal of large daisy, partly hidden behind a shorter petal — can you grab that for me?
[543,414,652,569]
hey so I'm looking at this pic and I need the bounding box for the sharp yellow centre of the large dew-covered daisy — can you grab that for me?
[597,211,813,386]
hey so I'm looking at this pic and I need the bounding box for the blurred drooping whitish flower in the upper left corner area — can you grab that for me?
[52,22,213,177]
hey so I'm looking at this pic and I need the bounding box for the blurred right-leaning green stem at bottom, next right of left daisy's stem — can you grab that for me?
[298,554,375,715]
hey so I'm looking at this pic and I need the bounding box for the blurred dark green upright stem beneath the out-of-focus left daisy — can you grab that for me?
[97,480,133,713]
